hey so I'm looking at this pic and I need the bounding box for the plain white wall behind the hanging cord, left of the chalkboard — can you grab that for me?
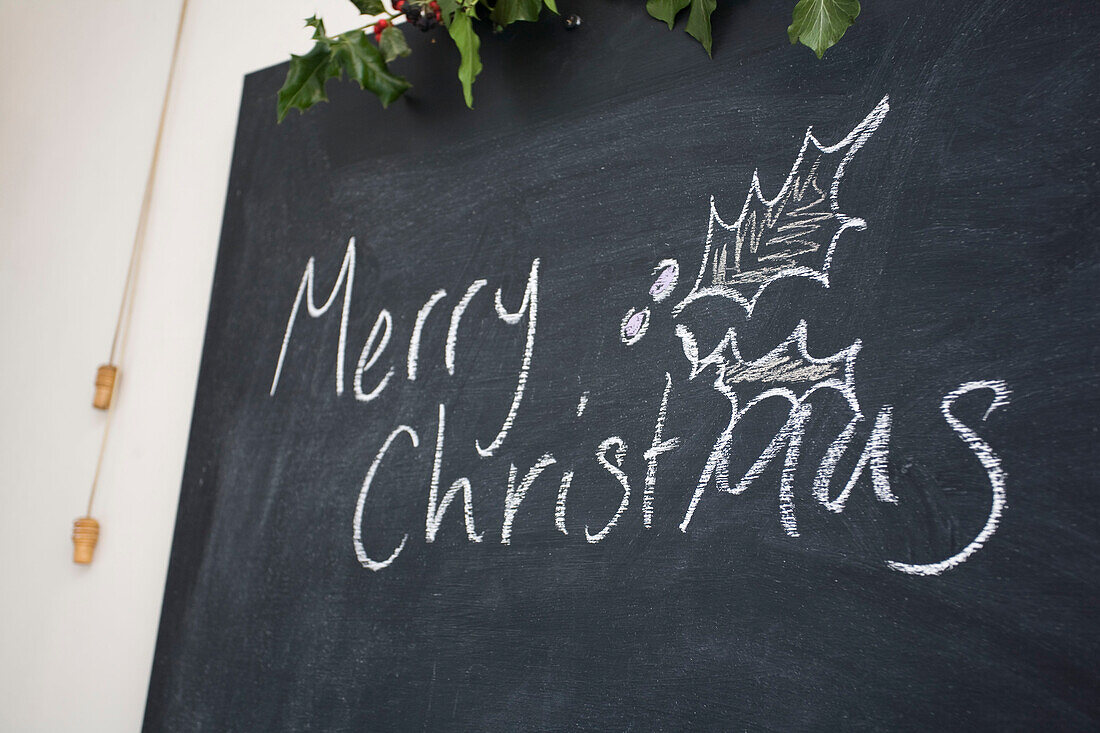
[0,0,374,731]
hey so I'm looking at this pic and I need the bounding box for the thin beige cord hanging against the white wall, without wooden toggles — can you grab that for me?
[85,0,189,516]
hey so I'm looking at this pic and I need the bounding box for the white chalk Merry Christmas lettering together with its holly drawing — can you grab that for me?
[270,98,1010,576]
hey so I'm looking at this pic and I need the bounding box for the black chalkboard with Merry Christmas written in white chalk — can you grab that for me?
[145,0,1100,731]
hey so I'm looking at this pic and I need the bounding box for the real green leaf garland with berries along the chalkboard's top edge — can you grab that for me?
[276,0,860,122]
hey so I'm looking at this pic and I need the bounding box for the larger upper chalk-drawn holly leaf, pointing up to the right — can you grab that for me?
[674,97,890,315]
